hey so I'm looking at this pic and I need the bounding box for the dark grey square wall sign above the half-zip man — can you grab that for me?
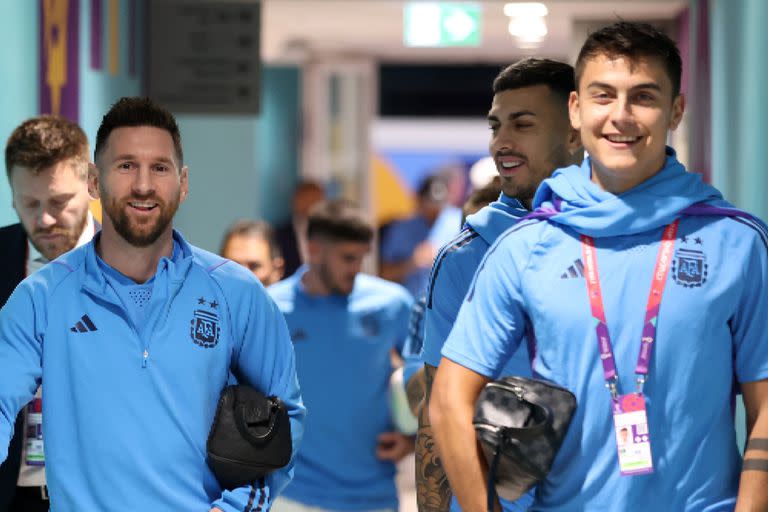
[147,0,261,114]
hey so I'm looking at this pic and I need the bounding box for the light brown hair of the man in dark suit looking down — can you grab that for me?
[5,115,88,181]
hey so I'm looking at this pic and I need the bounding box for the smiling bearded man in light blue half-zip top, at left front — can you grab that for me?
[0,98,304,512]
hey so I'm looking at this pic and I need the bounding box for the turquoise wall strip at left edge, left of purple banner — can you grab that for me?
[0,0,39,226]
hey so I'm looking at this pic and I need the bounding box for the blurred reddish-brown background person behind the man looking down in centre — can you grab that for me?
[275,181,325,277]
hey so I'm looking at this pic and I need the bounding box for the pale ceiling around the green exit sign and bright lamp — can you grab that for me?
[262,0,688,62]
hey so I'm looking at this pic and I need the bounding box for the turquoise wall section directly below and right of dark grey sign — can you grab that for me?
[175,67,301,252]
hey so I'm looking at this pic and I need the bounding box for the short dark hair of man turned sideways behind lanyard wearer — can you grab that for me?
[493,57,576,106]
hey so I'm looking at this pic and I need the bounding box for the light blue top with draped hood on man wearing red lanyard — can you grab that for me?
[443,149,768,512]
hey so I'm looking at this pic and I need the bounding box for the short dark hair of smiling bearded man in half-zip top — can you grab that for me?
[93,97,184,167]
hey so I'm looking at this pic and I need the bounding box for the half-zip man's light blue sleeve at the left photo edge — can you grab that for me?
[0,284,45,462]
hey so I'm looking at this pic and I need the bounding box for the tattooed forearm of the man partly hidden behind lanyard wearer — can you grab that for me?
[416,364,452,512]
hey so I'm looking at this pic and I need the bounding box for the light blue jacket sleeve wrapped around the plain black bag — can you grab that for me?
[211,285,306,512]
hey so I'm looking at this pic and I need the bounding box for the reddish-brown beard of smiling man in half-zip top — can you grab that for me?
[101,189,181,247]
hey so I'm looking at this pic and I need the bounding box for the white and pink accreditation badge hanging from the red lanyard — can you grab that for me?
[612,393,653,476]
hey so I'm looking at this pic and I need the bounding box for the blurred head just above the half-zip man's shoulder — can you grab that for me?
[219,219,285,286]
